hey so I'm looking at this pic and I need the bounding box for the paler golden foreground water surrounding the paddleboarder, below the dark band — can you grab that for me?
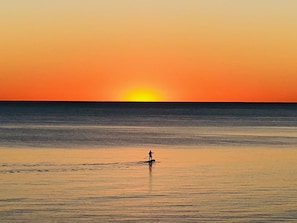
[0,148,297,223]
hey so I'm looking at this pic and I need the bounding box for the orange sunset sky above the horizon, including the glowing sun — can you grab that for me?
[0,0,297,102]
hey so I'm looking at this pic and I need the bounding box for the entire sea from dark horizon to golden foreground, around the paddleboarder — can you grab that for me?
[0,102,297,223]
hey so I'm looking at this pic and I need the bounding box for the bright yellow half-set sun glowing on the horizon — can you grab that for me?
[123,88,163,102]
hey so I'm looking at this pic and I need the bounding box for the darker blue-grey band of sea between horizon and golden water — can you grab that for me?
[0,102,297,148]
